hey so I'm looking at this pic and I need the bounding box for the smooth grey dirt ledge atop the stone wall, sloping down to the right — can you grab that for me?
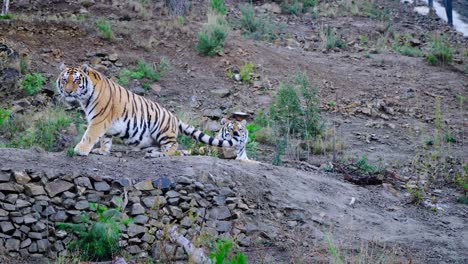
[0,149,468,263]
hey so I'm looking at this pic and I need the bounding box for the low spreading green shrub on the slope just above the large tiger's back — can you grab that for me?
[117,58,171,85]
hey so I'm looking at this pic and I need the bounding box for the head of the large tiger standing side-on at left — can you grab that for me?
[57,64,93,102]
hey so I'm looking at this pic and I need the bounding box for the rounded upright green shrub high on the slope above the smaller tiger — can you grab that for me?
[195,14,229,57]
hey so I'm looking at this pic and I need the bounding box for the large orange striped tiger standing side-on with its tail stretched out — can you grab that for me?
[57,65,239,157]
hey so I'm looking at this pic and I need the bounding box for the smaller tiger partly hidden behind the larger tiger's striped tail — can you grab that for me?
[216,118,249,160]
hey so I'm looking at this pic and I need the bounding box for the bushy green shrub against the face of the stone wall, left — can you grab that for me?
[57,204,128,261]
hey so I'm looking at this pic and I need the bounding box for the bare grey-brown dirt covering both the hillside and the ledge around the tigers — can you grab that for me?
[0,0,468,263]
